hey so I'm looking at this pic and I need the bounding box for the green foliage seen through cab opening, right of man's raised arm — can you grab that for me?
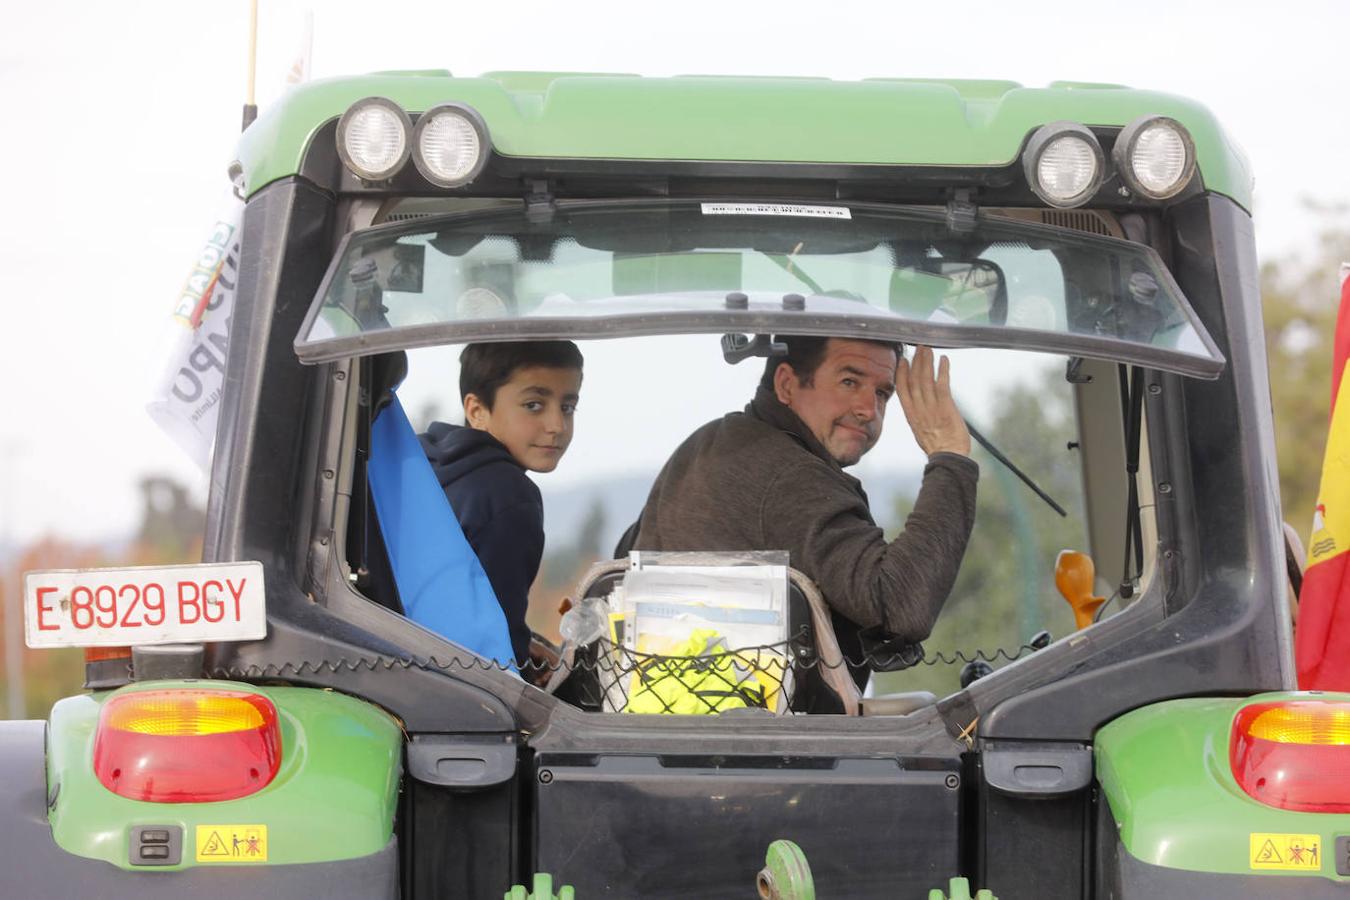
[876,367,1085,696]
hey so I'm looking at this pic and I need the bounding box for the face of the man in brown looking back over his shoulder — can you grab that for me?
[774,337,899,466]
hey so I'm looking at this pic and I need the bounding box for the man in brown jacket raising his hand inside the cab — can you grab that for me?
[635,336,979,683]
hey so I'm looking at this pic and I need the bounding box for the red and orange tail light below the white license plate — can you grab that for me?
[93,690,281,803]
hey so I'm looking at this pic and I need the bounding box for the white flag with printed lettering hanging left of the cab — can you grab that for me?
[147,193,244,471]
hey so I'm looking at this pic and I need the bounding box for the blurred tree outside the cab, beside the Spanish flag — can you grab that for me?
[1261,214,1350,542]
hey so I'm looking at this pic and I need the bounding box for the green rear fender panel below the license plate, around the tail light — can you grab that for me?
[47,681,402,870]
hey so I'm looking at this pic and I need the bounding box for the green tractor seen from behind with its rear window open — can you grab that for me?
[0,72,1333,900]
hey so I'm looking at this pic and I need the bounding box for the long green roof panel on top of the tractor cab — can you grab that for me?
[238,72,1251,209]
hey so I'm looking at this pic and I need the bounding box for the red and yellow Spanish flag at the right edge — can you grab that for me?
[1295,263,1350,691]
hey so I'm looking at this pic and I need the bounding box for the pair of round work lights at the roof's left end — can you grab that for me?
[338,97,491,188]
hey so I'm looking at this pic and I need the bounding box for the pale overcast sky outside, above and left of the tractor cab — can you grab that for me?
[0,0,1350,541]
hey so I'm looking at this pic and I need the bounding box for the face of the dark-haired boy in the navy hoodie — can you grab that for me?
[464,366,582,472]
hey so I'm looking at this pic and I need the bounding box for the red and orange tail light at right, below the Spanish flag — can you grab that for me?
[1229,700,1350,812]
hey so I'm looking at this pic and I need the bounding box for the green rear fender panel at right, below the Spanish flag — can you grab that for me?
[1095,694,1350,882]
